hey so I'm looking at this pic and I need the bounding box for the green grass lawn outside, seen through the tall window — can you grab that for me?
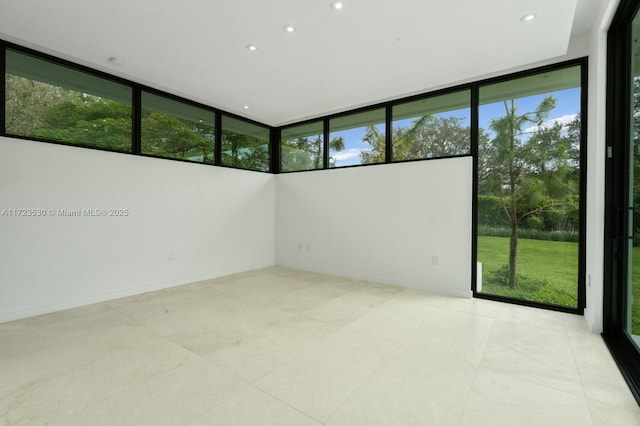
[478,236,580,306]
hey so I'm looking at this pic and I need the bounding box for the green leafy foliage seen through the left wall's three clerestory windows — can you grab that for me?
[6,74,270,171]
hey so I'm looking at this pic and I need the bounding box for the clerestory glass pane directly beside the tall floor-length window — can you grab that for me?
[392,90,471,161]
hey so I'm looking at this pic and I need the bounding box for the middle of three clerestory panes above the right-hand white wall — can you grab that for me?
[329,108,385,167]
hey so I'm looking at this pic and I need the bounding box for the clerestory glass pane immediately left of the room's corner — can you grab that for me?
[222,115,270,171]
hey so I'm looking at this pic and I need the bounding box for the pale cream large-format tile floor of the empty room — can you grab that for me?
[0,267,640,426]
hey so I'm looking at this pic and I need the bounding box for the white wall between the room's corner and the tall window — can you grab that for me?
[276,157,472,297]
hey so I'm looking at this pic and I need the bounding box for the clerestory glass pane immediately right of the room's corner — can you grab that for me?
[280,121,324,172]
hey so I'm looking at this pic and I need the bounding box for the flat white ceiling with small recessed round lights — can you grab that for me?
[0,0,608,125]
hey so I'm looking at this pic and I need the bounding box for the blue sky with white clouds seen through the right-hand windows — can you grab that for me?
[329,88,580,167]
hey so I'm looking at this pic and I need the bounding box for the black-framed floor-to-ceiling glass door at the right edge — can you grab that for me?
[604,0,640,401]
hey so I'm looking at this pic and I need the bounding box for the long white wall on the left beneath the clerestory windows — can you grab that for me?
[0,138,275,322]
